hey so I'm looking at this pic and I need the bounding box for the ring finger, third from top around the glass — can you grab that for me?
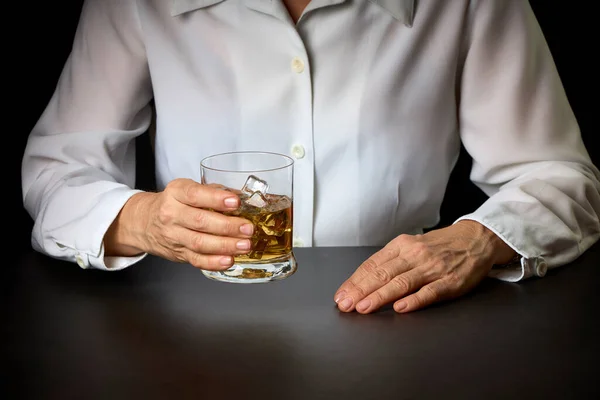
[179,229,252,256]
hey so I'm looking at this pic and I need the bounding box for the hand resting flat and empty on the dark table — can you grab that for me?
[334,220,516,314]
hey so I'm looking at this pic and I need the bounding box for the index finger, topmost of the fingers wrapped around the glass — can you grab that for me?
[165,179,240,211]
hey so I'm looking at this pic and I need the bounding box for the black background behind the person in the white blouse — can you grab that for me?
[10,0,600,249]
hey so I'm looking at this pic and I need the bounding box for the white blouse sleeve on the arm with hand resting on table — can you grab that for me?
[457,0,600,281]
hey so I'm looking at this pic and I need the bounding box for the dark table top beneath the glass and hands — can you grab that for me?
[0,244,600,400]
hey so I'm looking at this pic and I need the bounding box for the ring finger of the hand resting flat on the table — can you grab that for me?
[354,267,434,314]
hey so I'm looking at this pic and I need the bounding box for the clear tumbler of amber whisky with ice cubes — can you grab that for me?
[201,152,297,283]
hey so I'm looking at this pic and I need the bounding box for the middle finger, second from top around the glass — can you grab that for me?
[177,207,254,238]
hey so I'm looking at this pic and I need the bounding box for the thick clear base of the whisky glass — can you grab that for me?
[202,253,298,283]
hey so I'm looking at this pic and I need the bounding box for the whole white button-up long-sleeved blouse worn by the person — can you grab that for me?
[22,0,600,281]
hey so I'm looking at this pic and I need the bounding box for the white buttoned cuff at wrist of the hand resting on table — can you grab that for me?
[454,214,548,282]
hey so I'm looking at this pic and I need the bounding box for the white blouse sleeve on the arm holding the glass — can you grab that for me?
[22,0,152,269]
